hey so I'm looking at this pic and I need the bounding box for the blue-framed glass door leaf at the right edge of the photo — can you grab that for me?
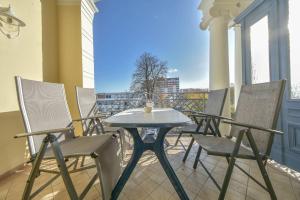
[279,0,300,170]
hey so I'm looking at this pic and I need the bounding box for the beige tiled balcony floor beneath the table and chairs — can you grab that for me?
[0,137,300,200]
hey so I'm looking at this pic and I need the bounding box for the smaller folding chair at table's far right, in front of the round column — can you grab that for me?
[175,88,228,169]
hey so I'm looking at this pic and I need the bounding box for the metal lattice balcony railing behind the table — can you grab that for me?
[97,92,207,112]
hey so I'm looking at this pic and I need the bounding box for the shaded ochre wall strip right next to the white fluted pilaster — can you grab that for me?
[57,4,82,133]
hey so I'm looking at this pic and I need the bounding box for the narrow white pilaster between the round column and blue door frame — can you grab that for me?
[234,25,243,107]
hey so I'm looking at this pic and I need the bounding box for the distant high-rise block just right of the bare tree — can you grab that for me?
[158,77,179,94]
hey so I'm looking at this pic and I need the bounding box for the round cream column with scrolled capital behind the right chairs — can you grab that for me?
[199,0,253,134]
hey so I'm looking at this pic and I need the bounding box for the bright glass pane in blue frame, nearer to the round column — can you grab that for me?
[250,16,270,83]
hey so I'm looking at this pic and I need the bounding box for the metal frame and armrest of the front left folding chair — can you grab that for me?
[14,76,115,200]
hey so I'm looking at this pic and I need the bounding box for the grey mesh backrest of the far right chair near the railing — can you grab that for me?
[204,88,228,116]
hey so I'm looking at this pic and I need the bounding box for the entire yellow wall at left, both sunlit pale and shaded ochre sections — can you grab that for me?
[0,0,96,176]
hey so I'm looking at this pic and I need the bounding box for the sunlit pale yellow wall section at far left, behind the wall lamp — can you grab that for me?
[0,0,43,175]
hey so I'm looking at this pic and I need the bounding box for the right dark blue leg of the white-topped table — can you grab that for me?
[153,128,189,200]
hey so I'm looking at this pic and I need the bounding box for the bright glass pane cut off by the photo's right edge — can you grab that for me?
[288,0,300,99]
